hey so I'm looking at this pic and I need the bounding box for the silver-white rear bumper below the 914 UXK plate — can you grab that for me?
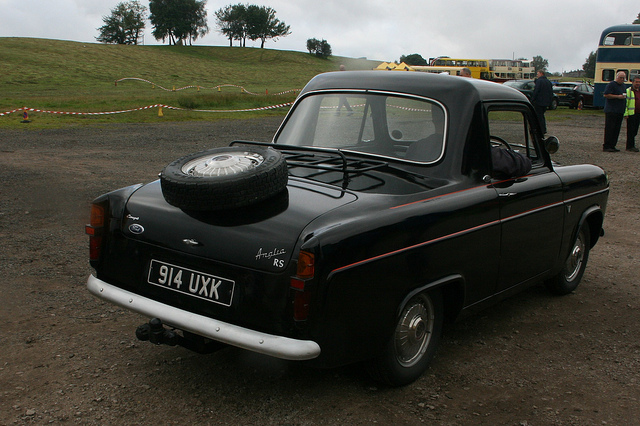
[87,275,320,361]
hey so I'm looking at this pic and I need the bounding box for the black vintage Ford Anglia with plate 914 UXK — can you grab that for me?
[86,71,609,386]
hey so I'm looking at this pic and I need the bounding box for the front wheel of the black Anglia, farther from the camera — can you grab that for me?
[545,222,591,296]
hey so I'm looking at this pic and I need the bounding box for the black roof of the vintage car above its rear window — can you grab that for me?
[301,70,527,106]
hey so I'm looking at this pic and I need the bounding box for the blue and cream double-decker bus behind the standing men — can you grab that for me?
[593,24,640,107]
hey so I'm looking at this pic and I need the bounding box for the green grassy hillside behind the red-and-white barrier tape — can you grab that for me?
[0,37,379,128]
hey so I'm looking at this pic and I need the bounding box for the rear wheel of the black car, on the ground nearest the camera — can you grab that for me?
[367,291,444,386]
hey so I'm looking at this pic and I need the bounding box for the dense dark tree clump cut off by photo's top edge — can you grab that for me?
[149,0,209,45]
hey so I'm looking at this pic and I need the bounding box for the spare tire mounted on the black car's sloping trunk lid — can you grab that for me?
[160,146,288,211]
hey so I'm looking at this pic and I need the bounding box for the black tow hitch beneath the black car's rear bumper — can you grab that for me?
[136,318,226,354]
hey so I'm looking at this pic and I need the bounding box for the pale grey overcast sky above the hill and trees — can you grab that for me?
[0,0,640,72]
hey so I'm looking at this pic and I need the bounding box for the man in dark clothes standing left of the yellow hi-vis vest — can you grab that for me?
[602,71,627,152]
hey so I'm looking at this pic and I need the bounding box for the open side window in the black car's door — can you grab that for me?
[488,108,544,167]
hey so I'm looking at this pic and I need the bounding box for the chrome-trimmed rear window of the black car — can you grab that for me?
[275,92,447,162]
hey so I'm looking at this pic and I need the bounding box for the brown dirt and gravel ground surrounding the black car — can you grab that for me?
[0,115,640,425]
